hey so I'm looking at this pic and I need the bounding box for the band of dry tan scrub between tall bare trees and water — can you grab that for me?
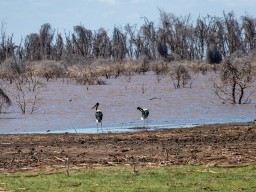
[0,56,256,85]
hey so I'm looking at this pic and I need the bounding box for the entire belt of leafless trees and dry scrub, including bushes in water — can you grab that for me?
[0,10,256,114]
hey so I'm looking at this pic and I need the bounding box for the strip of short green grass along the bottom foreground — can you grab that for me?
[0,165,256,192]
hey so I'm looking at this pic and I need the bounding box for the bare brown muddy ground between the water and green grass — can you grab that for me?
[0,122,256,173]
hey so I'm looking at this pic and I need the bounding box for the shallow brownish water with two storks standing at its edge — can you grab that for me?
[0,72,256,134]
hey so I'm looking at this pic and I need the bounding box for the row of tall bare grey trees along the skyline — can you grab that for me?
[0,10,256,63]
